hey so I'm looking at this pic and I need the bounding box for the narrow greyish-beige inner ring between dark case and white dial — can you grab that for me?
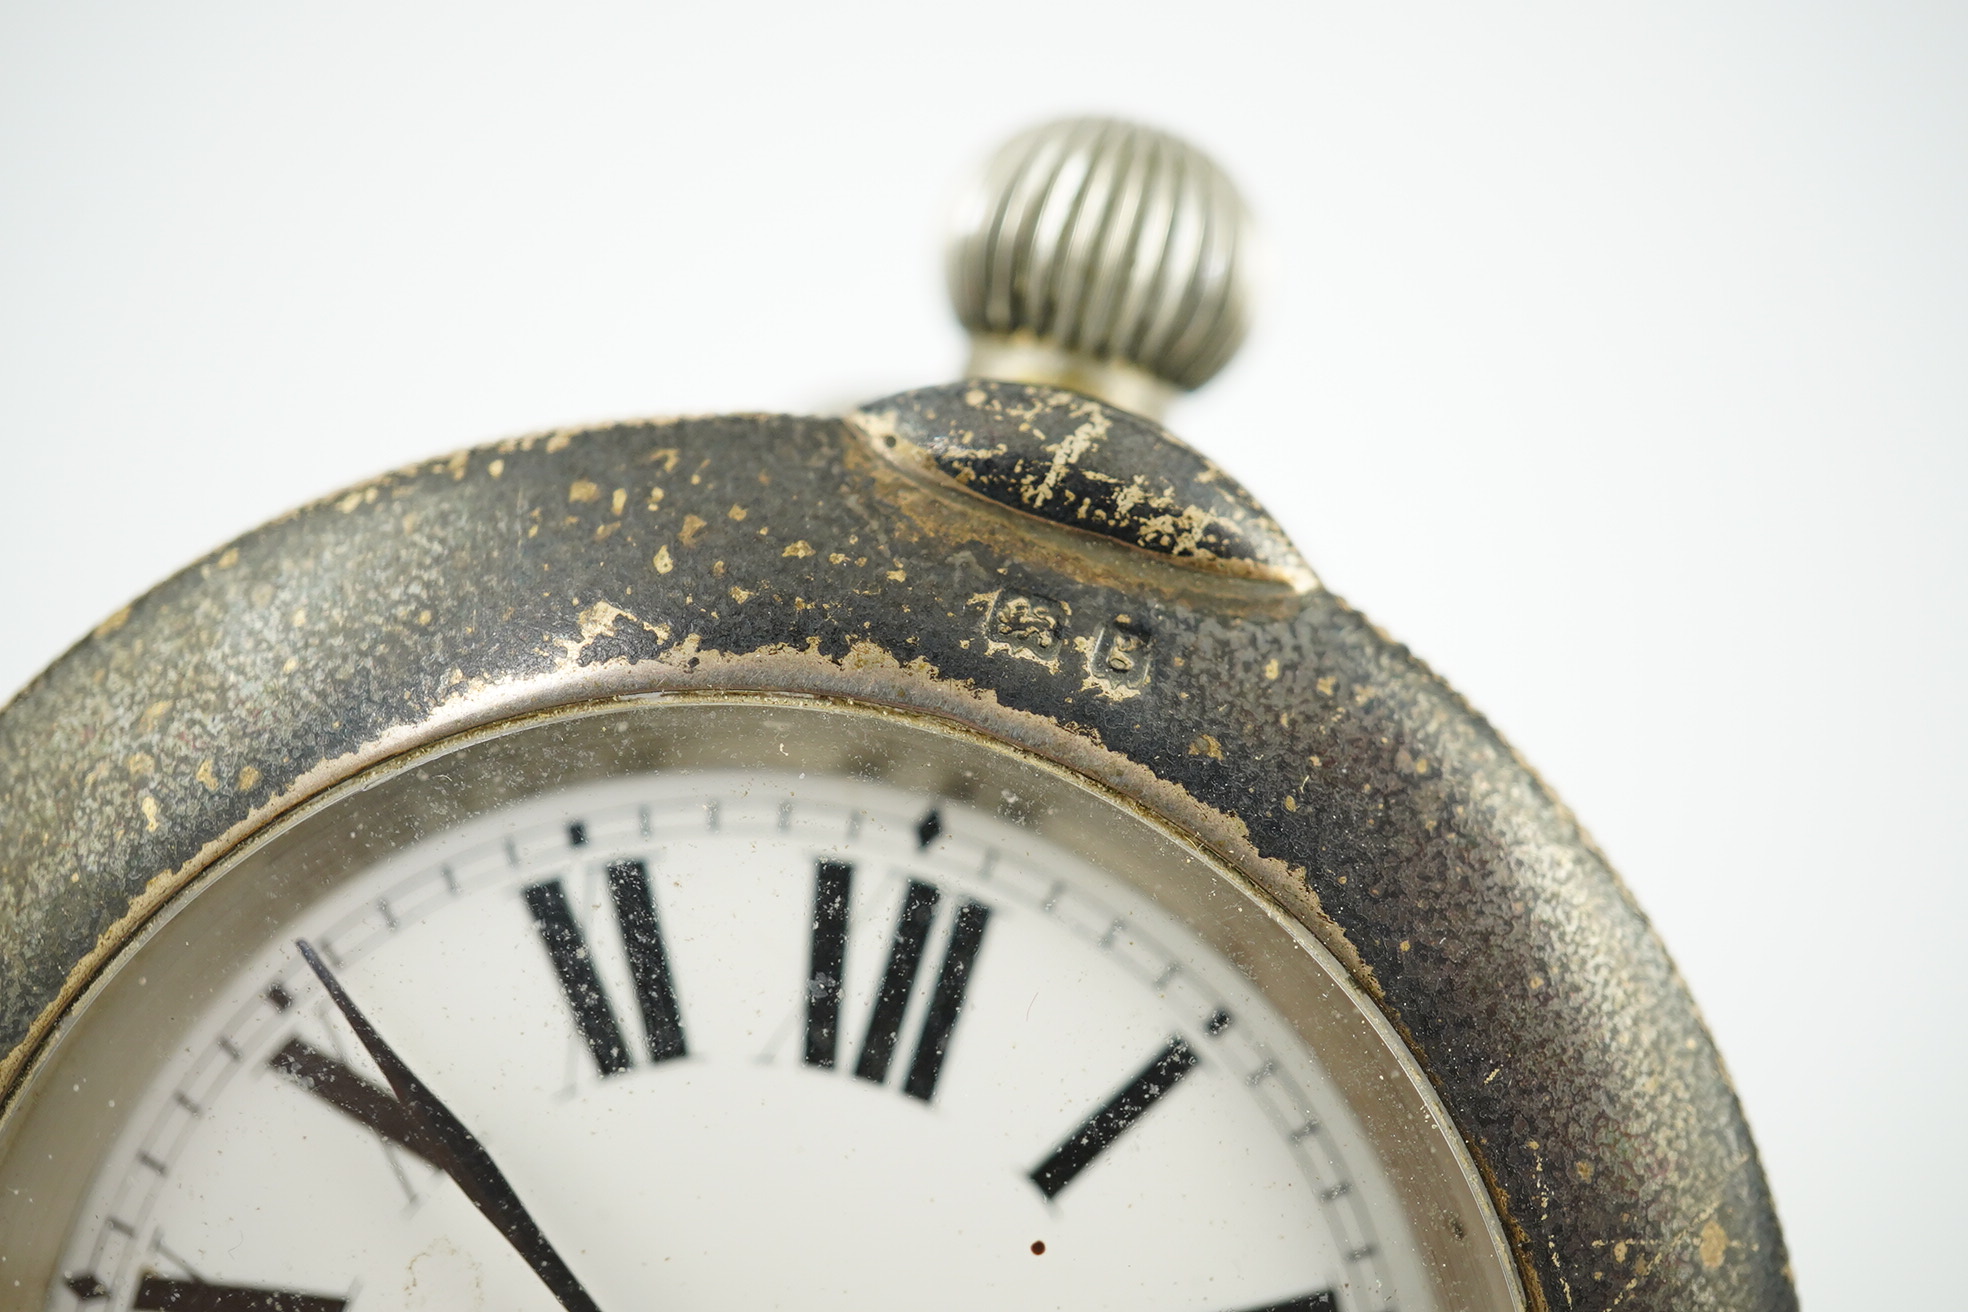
[0,692,1523,1308]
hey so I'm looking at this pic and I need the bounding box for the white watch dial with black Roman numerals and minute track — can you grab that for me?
[0,704,1519,1312]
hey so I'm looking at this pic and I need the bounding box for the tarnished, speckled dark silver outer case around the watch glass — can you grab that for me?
[0,384,1797,1312]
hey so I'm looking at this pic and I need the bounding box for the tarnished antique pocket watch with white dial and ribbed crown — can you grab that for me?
[0,120,1795,1312]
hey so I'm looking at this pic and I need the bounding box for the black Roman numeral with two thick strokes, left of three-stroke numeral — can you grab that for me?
[525,862,687,1076]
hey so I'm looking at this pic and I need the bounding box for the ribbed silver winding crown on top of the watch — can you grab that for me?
[949,118,1250,405]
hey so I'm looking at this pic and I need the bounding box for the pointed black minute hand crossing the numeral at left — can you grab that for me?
[295,938,600,1312]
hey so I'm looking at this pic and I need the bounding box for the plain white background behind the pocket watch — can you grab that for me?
[0,0,1968,1308]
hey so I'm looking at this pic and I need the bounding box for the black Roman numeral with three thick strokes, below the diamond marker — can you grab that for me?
[805,862,990,1102]
